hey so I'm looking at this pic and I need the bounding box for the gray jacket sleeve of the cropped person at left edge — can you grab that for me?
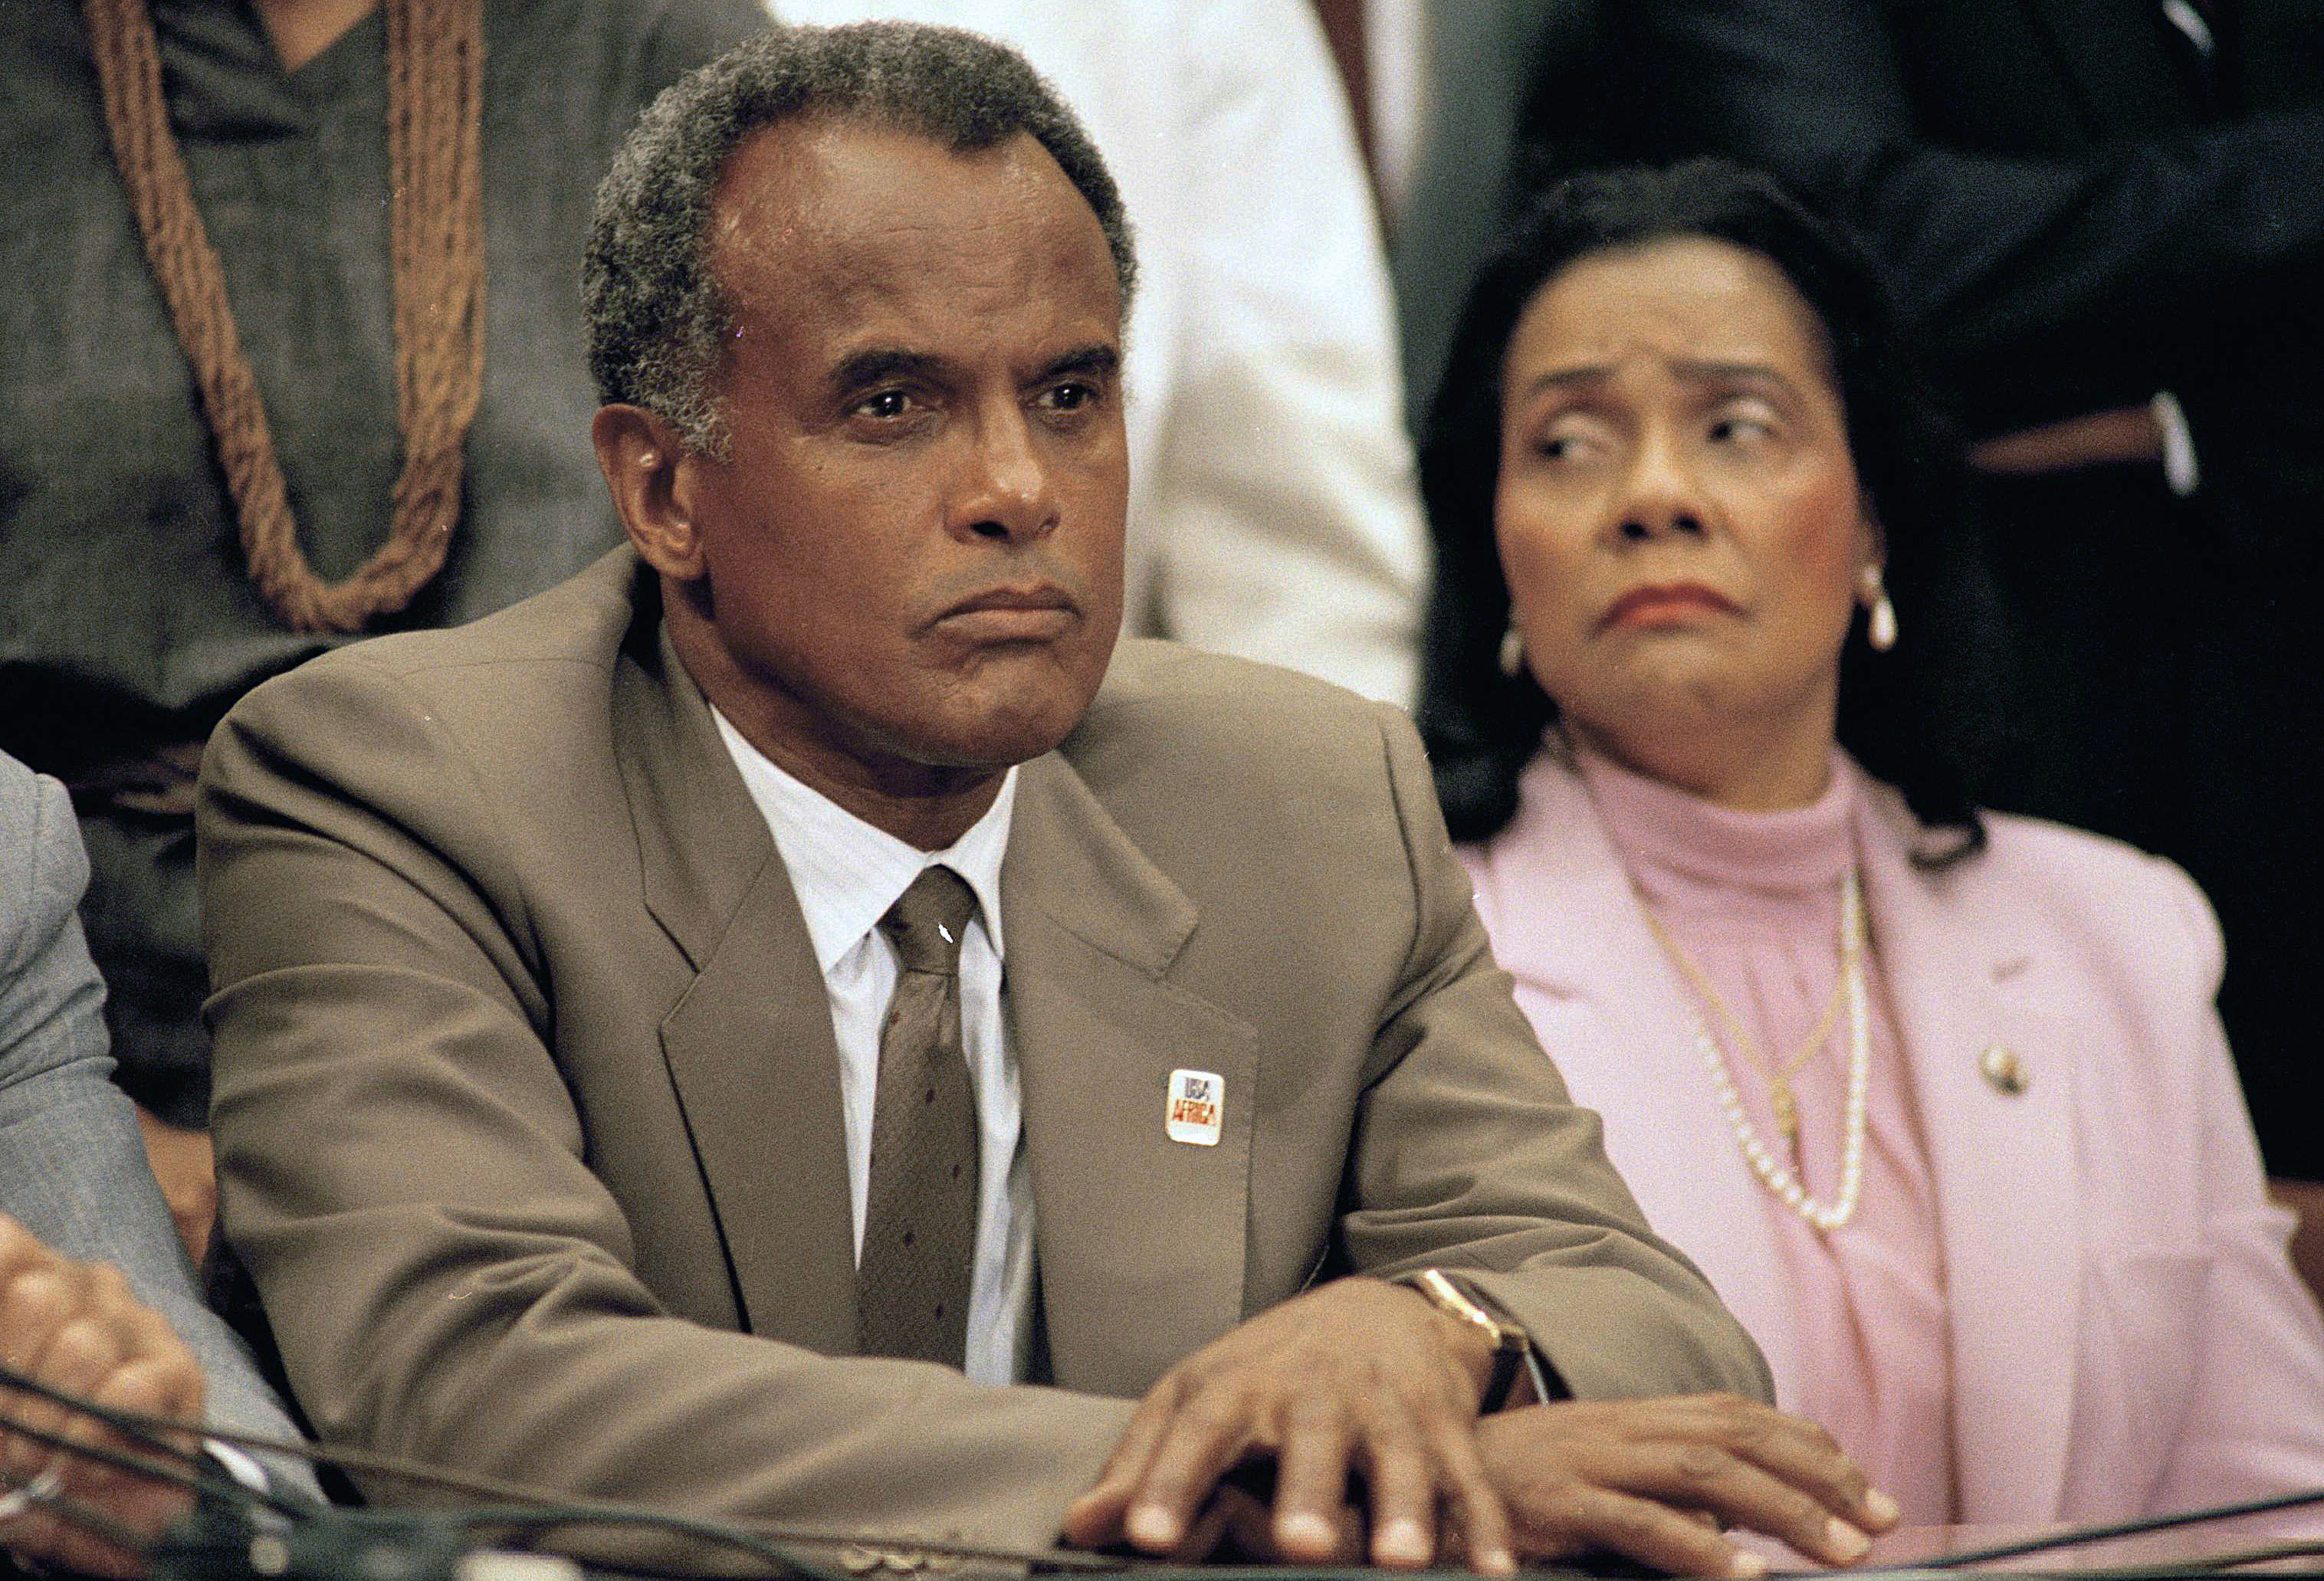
[0,758,313,1493]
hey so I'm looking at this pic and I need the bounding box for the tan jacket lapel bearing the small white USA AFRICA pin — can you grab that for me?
[1002,753,1257,1397]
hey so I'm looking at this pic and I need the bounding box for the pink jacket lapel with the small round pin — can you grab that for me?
[1857,791,2080,1523]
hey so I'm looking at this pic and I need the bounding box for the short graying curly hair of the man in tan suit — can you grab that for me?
[581,21,1137,458]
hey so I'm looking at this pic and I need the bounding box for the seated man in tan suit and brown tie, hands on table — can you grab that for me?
[200,25,1885,1572]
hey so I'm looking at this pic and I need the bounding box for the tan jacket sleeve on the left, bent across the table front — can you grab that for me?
[200,661,1130,1546]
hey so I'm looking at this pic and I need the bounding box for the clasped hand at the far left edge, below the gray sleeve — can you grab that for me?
[0,1216,202,1576]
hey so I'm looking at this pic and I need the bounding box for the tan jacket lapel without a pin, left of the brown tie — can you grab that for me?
[604,609,855,1356]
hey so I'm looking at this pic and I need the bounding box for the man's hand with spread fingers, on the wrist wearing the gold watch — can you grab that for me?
[1065,1279,1515,1574]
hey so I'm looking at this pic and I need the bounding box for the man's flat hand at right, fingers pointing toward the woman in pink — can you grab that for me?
[1478,1395,1896,1576]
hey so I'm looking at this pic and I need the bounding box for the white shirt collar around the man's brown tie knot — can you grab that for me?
[711,707,1016,972]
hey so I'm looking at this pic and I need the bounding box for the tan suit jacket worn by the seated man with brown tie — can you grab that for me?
[200,551,1768,1543]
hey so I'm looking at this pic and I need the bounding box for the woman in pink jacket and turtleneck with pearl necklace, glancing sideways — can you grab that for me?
[1423,162,2324,1523]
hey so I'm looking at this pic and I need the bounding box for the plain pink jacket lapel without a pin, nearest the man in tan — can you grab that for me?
[1485,751,1799,1383]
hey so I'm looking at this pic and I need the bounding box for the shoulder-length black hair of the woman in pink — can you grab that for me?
[1420,160,1989,865]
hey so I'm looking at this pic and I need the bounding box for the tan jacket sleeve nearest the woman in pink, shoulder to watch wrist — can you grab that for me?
[1341,709,1773,1399]
